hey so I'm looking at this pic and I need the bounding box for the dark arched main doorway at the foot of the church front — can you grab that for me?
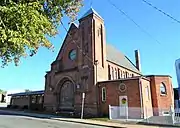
[59,80,74,110]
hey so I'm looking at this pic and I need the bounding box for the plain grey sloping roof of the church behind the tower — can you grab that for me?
[106,44,141,74]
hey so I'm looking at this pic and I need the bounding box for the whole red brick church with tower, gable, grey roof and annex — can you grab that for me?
[44,8,174,117]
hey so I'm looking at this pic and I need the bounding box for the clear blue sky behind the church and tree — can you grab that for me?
[0,0,180,90]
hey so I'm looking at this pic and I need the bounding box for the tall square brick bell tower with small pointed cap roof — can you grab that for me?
[79,8,108,84]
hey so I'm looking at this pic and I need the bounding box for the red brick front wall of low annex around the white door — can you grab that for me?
[99,79,140,115]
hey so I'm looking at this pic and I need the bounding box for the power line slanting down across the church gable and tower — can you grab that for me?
[60,21,94,70]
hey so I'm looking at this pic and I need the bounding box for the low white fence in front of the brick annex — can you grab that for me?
[109,105,180,125]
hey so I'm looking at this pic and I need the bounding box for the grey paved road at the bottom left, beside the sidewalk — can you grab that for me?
[0,112,110,128]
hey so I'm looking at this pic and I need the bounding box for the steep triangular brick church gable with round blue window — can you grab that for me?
[51,24,79,71]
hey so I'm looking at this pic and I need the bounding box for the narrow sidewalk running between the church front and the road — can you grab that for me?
[0,110,169,128]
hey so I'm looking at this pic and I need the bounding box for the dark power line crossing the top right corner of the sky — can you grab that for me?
[142,0,180,23]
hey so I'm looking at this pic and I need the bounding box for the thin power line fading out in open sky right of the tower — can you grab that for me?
[107,0,160,44]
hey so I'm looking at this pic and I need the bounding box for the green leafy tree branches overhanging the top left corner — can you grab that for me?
[0,0,82,67]
